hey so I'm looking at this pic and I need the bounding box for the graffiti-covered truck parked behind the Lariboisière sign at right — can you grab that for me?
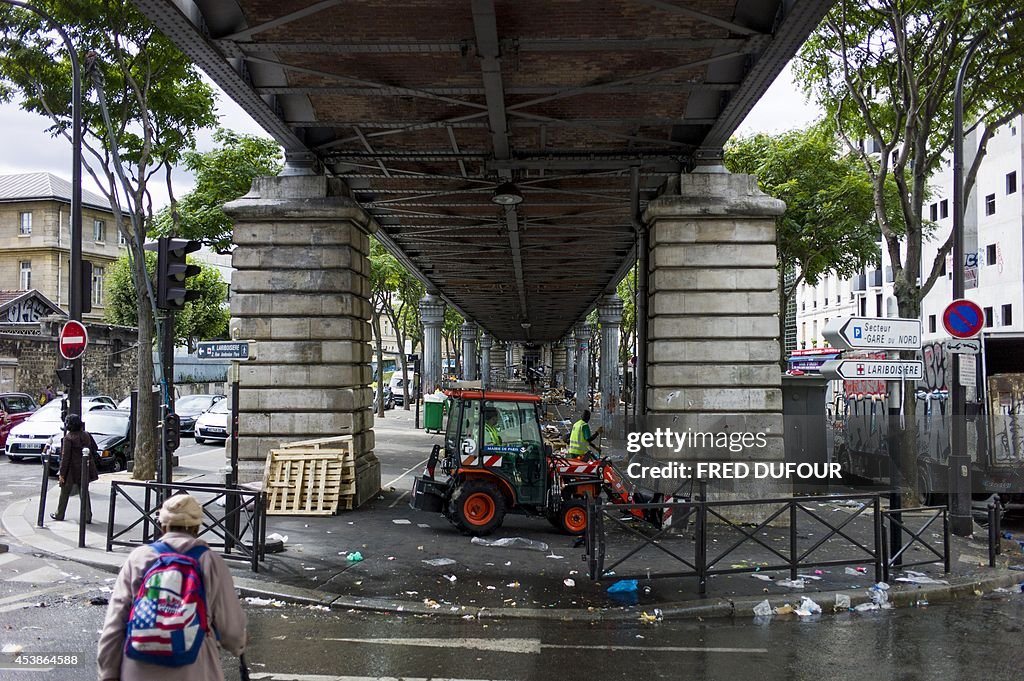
[827,335,1024,504]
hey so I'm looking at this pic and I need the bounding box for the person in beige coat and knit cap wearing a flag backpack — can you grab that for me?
[96,495,247,681]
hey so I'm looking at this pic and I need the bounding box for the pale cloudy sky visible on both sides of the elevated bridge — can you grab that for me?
[0,63,820,207]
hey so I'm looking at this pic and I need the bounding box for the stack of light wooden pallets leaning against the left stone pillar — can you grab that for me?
[263,435,355,515]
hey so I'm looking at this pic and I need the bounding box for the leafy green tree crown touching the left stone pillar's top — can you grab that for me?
[155,128,282,253]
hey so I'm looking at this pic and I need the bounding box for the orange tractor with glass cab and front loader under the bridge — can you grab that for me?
[411,390,662,537]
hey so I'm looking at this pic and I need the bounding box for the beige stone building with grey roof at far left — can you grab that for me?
[0,173,125,322]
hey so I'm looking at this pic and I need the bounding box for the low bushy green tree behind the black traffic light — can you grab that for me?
[103,251,231,349]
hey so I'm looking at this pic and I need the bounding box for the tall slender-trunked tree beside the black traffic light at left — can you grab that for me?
[0,0,215,479]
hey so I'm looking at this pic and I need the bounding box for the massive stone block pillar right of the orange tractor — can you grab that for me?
[642,172,790,509]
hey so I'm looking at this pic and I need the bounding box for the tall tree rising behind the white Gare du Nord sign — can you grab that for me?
[798,0,1024,497]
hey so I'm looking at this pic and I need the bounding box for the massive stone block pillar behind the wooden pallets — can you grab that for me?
[224,175,380,505]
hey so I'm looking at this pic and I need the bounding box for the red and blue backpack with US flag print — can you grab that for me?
[125,542,209,667]
